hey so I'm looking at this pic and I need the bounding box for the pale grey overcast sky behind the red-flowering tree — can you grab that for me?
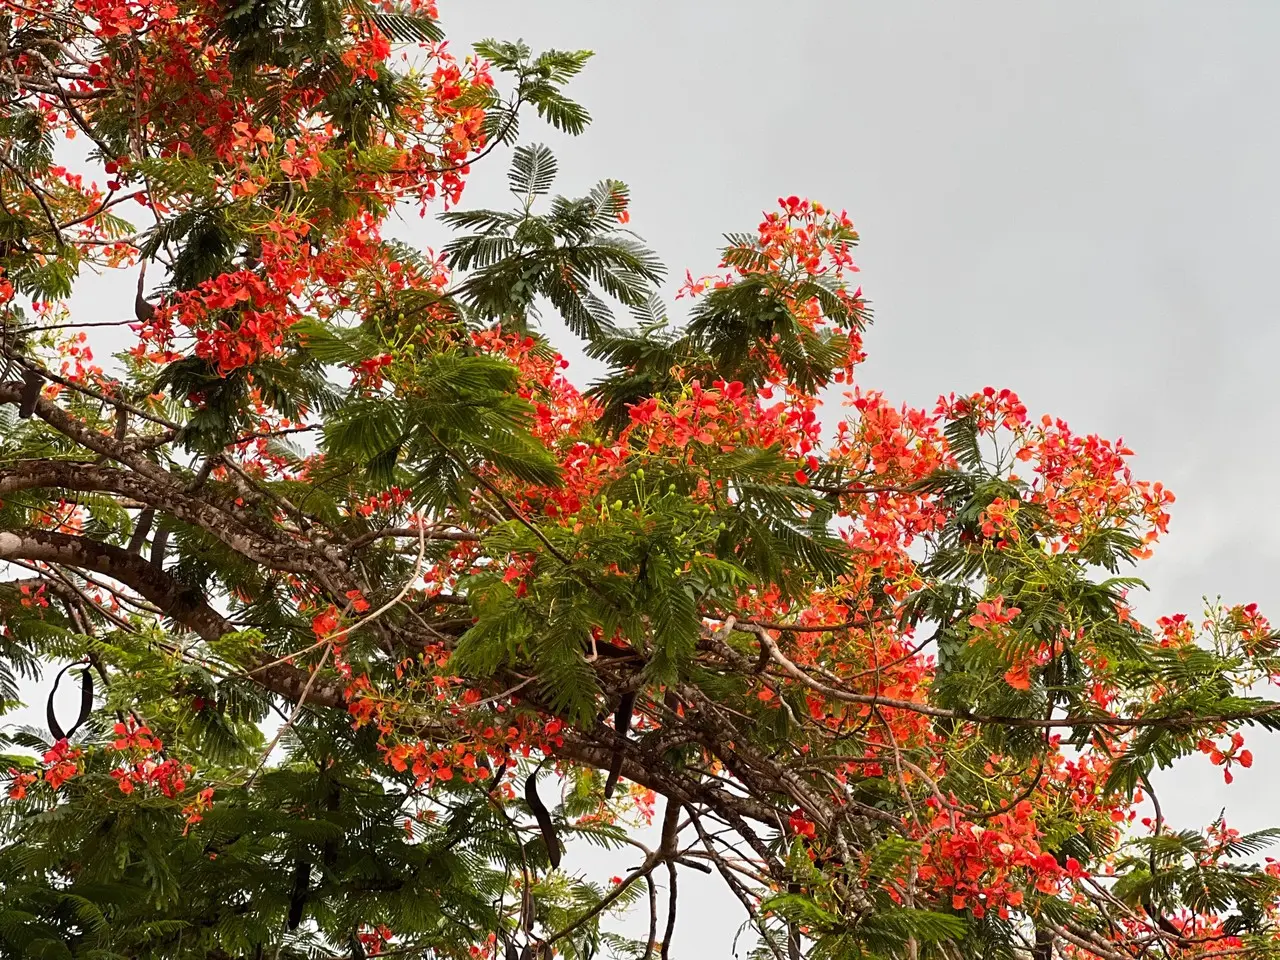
[27,0,1280,957]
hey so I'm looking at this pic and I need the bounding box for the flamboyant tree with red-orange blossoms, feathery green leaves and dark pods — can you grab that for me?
[0,0,1280,960]
